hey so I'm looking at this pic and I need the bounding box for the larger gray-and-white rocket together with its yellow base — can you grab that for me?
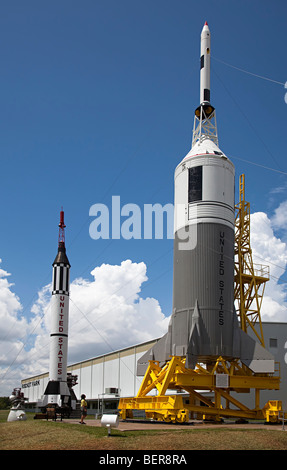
[119,23,280,422]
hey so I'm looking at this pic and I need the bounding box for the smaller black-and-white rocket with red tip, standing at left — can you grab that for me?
[42,210,71,408]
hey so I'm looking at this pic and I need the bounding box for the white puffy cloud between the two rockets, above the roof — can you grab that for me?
[64,260,171,362]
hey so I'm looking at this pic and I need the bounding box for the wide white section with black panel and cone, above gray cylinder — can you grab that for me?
[174,139,235,233]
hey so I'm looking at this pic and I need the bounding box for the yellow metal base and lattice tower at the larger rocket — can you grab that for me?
[119,175,282,423]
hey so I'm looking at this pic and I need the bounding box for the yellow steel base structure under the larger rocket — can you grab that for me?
[119,356,282,423]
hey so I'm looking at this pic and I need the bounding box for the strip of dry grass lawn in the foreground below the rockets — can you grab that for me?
[0,411,287,451]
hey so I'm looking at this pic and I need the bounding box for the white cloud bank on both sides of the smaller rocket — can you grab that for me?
[0,260,169,395]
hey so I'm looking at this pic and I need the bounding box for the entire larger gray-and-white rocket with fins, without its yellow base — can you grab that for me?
[137,23,274,375]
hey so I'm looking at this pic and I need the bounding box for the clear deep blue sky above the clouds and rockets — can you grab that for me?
[0,0,287,392]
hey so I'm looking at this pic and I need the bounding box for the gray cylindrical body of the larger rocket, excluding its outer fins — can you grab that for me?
[171,223,237,367]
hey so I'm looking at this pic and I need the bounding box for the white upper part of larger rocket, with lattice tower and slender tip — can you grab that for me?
[174,22,235,234]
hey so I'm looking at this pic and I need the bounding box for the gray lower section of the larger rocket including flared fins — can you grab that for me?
[137,223,274,375]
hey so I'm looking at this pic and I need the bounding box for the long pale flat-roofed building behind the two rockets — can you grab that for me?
[21,322,287,414]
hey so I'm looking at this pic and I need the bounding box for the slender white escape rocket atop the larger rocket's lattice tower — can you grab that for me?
[200,23,210,104]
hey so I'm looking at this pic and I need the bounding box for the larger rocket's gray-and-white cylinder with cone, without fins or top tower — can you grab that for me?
[170,139,235,365]
